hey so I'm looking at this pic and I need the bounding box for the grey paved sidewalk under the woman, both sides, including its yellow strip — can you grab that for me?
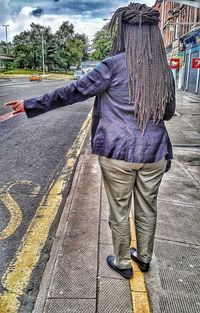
[34,92,200,313]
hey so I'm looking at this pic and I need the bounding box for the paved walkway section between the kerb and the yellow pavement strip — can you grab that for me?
[36,149,138,313]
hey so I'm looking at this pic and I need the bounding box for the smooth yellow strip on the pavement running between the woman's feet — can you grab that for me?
[130,216,150,313]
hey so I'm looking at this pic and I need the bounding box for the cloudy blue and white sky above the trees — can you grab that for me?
[0,0,155,41]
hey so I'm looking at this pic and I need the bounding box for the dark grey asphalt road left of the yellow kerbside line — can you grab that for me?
[0,80,93,313]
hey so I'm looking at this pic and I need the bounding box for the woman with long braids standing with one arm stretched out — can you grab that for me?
[6,3,175,278]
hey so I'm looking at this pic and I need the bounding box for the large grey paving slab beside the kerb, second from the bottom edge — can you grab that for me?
[48,242,97,299]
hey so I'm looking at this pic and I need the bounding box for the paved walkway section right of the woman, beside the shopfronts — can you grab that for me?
[145,92,200,313]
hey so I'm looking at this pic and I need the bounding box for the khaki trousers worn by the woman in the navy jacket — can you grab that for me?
[99,156,167,269]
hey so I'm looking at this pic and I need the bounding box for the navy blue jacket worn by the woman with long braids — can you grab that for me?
[24,53,175,163]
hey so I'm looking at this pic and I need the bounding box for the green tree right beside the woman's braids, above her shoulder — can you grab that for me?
[90,24,112,61]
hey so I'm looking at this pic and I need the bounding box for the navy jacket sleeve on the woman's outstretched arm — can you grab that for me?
[24,59,112,117]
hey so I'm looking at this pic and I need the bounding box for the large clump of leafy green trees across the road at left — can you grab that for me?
[8,21,88,71]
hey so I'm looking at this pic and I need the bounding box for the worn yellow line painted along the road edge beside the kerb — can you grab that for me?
[0,112,91,313]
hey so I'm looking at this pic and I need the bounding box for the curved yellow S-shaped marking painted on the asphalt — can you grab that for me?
[0,181,40,240]
